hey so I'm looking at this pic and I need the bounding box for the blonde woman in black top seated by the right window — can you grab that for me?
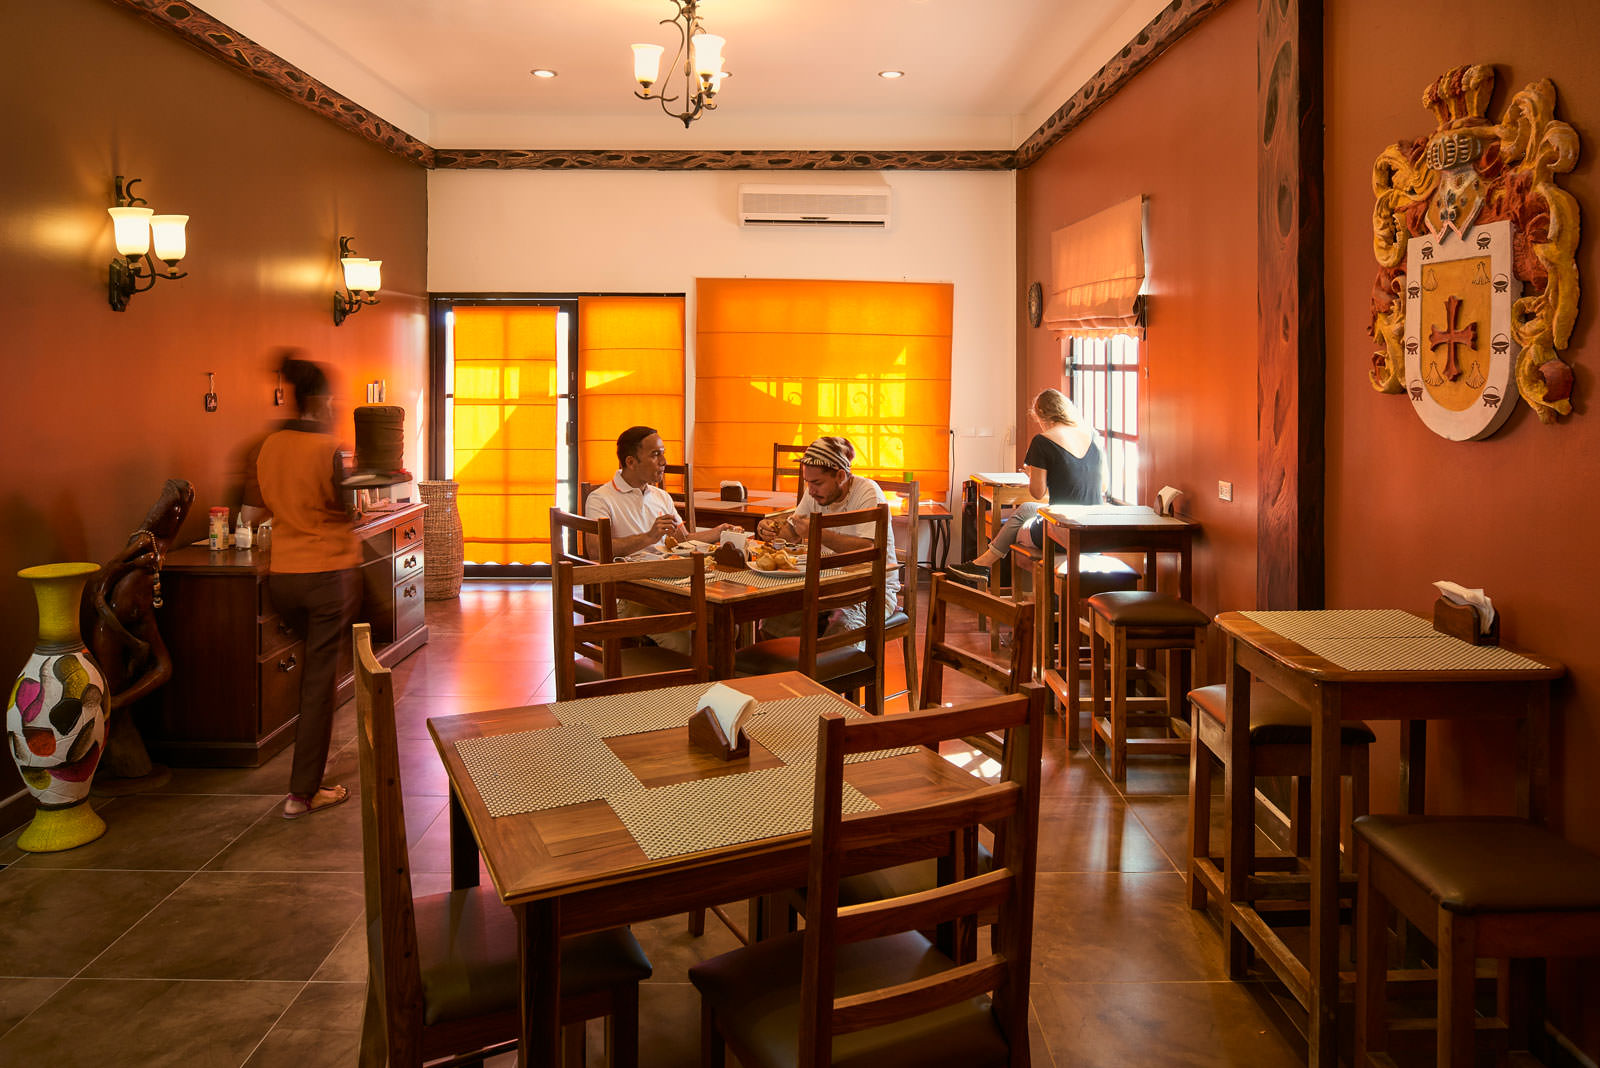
[947,390,1106,587]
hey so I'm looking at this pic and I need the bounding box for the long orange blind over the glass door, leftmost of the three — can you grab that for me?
[453,307,560,564]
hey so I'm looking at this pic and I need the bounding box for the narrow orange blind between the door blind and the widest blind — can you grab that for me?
[578,297,685,484]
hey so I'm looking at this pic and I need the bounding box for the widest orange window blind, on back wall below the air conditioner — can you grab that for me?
[694,278,955,499]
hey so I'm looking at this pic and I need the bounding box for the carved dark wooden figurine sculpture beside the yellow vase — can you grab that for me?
[83,478,195,791]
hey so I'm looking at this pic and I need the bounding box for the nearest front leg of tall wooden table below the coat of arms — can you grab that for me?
[1306,686,1341,1068]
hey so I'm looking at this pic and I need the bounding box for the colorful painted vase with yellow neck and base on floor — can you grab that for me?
[5,563,106,852]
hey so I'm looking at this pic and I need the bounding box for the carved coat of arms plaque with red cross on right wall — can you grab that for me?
[1370,66,1579,441]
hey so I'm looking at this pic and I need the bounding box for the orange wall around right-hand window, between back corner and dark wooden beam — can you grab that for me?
[1018,3,1256,629]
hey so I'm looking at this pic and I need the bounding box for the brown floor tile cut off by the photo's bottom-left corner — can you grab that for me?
[0,978,300,1068]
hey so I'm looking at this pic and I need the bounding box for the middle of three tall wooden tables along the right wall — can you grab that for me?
[1034,505,1200,748]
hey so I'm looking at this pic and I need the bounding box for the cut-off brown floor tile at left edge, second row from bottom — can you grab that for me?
[0,868,190,978]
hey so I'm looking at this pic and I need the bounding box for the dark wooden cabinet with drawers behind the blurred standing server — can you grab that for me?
[146,504,427,767]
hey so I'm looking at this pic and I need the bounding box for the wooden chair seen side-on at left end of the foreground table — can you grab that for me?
[354,624,651,1068]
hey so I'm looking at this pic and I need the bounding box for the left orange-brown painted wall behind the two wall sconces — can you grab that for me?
[0,0,427,827]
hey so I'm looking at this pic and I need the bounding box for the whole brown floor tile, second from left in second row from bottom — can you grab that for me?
[83,869,362,980]
